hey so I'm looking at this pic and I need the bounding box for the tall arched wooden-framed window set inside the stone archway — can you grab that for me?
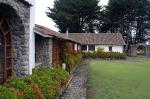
[0,19,13,83]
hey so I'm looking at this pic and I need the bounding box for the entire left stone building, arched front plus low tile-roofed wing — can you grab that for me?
[0,0,77,82]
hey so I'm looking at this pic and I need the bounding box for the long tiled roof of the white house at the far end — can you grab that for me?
[69,33,125,45]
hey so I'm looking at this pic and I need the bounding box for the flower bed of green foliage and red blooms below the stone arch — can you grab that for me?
[0,67,69,99]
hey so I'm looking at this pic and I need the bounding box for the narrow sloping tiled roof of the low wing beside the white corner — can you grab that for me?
[34,24,75,42]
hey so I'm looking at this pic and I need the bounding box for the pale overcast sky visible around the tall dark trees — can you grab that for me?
[35,0,108,31]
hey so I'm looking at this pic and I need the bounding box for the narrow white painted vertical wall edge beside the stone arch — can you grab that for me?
[27,0,35,74]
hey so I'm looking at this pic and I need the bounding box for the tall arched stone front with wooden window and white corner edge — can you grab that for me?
[0,0,35,81]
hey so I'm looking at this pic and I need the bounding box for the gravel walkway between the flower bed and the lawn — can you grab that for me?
[63,61,88,99]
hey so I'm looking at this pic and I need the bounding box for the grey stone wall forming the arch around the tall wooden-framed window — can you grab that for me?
[0,0,30,76]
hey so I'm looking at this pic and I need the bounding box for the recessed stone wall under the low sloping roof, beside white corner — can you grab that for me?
[35,34,52,66]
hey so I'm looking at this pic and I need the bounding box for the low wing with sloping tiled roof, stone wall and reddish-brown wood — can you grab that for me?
[34,25,77,66]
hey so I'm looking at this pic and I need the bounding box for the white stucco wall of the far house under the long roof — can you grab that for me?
[95,45,123,53]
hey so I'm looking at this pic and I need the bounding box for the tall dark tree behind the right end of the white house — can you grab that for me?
[99,0,150,49]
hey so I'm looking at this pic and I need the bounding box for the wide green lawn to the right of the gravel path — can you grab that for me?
[87,57,150,99]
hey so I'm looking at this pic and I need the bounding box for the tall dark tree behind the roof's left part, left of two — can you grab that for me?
[47,0,101,33]
